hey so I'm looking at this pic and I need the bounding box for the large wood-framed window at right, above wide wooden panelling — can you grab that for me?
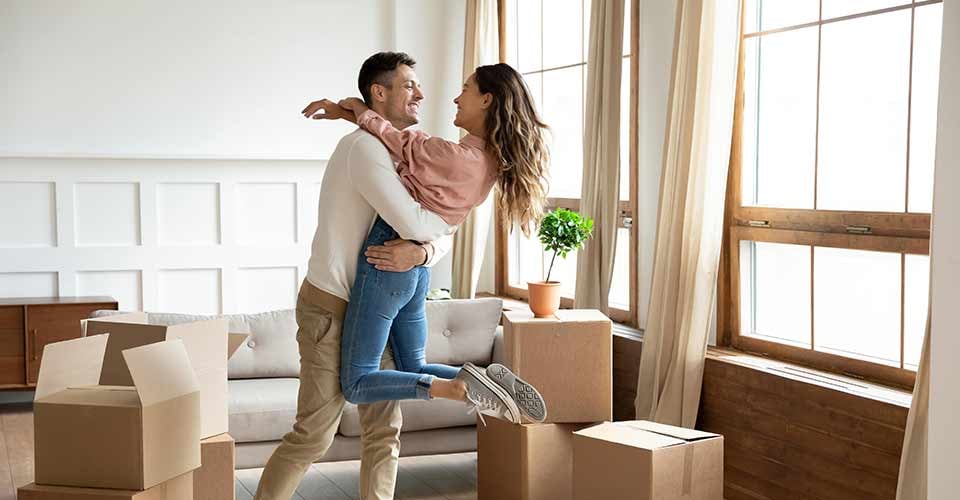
[720,0,943,387]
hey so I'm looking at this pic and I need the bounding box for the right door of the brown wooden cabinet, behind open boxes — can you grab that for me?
[26,303,116,384]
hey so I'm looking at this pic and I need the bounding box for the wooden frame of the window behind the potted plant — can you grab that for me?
[495,0,640,327]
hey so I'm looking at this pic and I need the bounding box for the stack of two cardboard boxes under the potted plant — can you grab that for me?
[477,310,613,500]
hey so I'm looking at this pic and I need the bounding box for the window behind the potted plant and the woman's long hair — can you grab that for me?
[497,0,638,324]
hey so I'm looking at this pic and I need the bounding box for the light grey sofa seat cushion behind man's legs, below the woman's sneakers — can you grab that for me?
[340,399,477,437]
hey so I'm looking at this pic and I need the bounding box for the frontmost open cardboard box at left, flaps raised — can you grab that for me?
[33,335,200,490]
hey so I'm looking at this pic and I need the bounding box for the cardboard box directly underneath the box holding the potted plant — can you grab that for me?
[477,416,590,500]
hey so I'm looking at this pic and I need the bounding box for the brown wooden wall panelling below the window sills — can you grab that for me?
[613,335,908,500]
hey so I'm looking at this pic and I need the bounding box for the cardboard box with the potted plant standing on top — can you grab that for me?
[503,309,613,423]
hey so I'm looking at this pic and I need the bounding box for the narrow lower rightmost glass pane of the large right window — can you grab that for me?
[903,255,930,370]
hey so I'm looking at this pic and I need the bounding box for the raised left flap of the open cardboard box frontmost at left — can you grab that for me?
[33,335,107,401]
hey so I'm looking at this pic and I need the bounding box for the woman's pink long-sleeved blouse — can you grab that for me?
[357,110,497,225]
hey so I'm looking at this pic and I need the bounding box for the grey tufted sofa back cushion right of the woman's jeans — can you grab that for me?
[426,298,503,366]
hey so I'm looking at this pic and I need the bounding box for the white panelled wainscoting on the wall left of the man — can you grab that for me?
[0,159,333,314]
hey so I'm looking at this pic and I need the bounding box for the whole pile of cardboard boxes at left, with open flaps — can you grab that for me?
[21,313,246,500]
